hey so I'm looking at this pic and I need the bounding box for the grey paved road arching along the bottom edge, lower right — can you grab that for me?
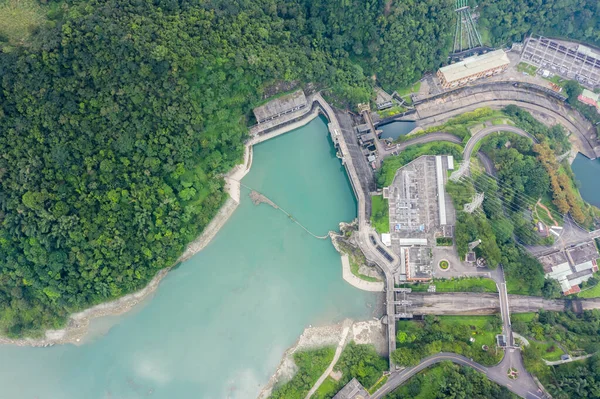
[371,353,542,399]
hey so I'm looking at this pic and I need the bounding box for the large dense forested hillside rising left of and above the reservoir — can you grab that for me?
[0,0,453,336]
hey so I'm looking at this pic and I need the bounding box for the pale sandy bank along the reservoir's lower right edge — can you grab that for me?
[258,319,387,399]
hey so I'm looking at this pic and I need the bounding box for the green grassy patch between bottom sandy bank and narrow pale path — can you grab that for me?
[271,347,335,399]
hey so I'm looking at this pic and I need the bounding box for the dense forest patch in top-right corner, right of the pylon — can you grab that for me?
[477,0,600,46]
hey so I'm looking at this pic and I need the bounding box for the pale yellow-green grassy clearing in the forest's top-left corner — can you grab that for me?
[0,0,46,45]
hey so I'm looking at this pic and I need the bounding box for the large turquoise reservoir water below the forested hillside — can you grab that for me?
[0,119,377,399]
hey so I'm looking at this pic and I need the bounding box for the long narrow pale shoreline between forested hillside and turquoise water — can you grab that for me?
[0,102,318,347]
